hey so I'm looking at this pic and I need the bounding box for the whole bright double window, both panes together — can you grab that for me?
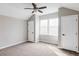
[40,18,58,36]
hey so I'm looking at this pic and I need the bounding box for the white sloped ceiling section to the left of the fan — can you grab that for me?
[0,3,32,19]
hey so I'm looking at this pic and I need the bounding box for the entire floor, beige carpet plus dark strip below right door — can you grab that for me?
[0,42,79,56]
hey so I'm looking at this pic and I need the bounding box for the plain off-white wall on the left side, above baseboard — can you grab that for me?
[0,15,27,49]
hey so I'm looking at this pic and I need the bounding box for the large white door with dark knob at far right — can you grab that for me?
[61,15,78,51]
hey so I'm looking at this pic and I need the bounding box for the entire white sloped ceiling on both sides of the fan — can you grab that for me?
[0,3,79,20]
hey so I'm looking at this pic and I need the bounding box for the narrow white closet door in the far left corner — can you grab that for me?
[28,21,34,42]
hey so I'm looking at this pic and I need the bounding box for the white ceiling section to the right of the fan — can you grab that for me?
[37,3,79,15]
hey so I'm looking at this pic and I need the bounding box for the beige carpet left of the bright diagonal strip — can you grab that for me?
[0,43,57,56]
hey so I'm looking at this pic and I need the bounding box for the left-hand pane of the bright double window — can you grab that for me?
[40,20,48,35]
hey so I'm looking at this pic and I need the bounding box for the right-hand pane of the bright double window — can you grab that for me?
[49,18,58,36]
